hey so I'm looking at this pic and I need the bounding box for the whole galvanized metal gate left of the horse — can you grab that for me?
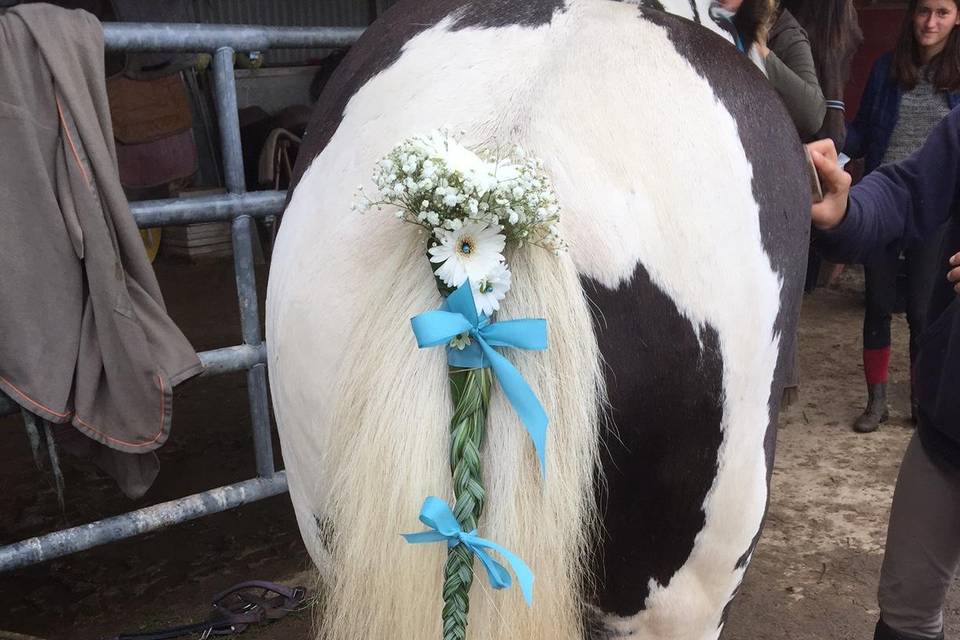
[0,23,363,571]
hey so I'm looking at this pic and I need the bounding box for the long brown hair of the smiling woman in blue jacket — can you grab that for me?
[890,0,960,93]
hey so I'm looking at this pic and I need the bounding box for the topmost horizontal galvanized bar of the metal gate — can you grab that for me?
[103,22,363,53]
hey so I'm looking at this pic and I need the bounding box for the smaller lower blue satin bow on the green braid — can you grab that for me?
[400,496,533,607]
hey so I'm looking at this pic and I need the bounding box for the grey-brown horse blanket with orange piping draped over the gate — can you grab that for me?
[0,4,202,492]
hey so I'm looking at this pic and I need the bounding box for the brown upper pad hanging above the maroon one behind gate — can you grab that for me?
[107,74,193,144]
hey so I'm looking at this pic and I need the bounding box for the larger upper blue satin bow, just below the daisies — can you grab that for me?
[410,280,548,475]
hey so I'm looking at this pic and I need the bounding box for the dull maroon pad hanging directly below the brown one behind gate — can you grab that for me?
[117,129,197,189]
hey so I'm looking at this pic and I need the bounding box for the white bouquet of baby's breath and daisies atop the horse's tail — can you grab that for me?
[354,129,567,316]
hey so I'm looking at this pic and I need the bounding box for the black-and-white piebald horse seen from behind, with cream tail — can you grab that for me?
[267,0,810,640]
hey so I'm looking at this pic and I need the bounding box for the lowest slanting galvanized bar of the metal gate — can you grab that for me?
[0,471,287,571]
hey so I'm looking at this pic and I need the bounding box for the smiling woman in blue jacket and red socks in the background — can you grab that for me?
[843,0,960,433]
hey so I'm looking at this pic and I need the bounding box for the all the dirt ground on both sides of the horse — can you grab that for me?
[0,262,960,640]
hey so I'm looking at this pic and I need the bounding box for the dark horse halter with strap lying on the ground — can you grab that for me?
[113,580,307,640]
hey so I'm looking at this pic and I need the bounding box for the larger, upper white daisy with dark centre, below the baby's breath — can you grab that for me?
[430,222,507,287]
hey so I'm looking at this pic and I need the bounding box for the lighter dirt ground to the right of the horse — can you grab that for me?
[725,269,960,640]
